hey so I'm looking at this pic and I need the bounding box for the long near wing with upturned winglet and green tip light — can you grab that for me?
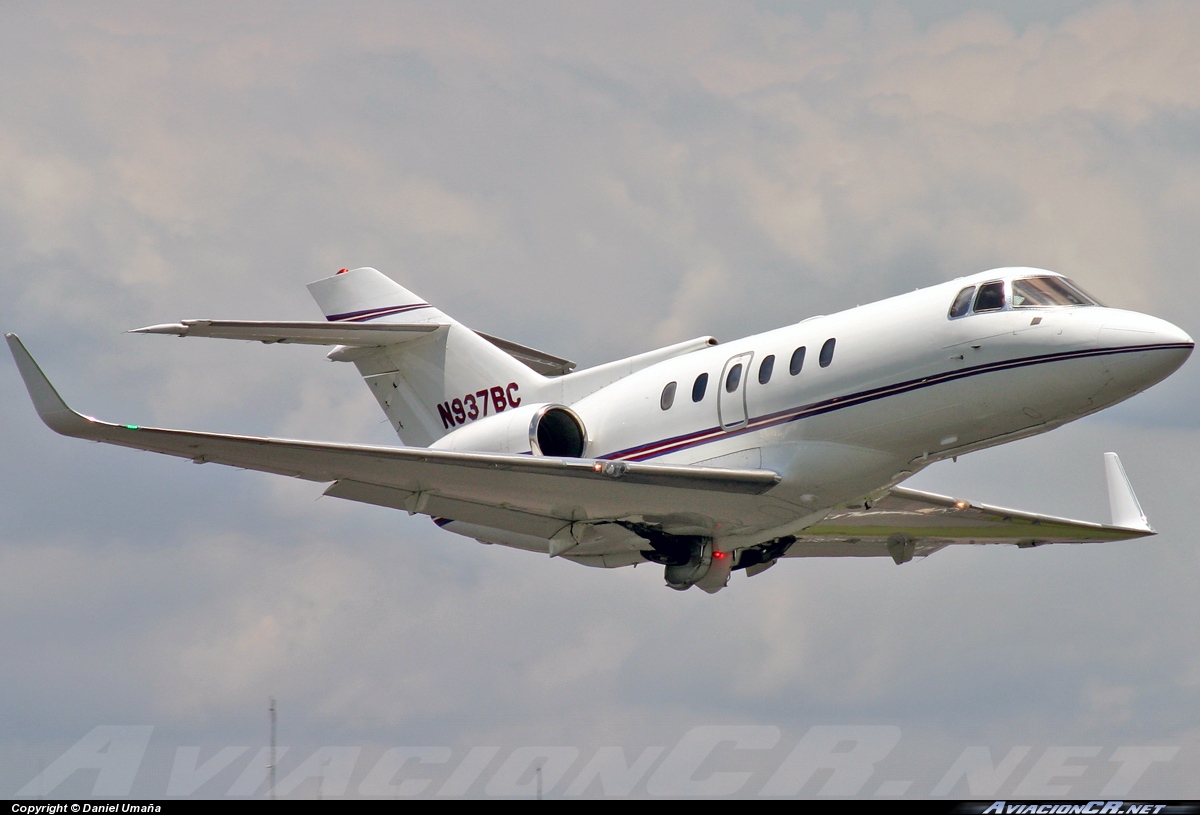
[7,334,779,538]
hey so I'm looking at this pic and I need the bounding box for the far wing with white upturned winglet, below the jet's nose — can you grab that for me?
[787,465,1156,563]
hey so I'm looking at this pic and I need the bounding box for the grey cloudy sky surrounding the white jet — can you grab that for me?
[0,0,1200,798]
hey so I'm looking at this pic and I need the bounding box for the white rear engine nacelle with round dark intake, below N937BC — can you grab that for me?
[430,403,588,459]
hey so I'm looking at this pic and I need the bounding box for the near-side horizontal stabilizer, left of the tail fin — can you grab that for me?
[130,319,446,348]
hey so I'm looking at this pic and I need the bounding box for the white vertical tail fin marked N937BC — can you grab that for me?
[308,268,545,447]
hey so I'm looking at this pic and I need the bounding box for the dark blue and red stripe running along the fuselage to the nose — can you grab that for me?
[596,342,1194,461]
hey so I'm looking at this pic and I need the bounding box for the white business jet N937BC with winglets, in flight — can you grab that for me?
[8,268,1193,593]
